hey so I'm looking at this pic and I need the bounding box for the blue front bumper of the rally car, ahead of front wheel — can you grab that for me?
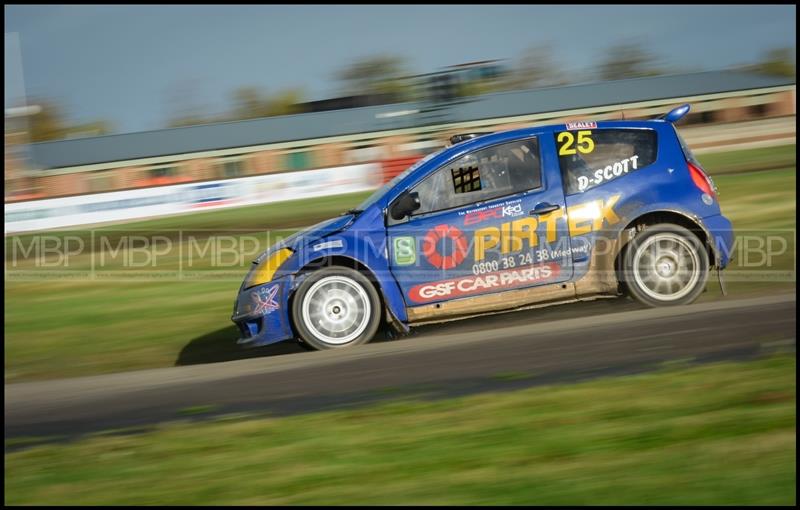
[231,276,295,347]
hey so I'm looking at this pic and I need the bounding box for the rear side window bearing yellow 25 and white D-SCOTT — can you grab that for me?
[555,129,658,195]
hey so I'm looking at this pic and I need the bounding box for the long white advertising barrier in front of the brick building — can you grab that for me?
[5,163,382,234]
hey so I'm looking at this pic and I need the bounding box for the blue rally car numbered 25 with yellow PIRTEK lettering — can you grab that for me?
[232,105,733,349]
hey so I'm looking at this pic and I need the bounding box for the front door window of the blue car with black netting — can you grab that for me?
[412,138,542,216]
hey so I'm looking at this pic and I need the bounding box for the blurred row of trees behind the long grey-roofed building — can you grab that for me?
[23,45,796,142]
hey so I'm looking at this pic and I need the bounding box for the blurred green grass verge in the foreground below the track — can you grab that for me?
[5,356,797,505]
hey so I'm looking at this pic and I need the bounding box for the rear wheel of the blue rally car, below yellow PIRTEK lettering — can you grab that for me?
[621,224,709,306]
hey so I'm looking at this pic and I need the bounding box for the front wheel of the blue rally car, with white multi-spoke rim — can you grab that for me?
[292,267,381,350]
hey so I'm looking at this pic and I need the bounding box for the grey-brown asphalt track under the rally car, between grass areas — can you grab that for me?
[5,294,796,444]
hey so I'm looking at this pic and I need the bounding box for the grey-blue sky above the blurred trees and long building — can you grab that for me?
[5,5,796,132]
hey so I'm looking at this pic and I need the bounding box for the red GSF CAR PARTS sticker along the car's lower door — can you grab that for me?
[408,263,561,303]
